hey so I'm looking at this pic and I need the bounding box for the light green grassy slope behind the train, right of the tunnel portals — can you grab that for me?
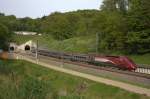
[13,35,95,53]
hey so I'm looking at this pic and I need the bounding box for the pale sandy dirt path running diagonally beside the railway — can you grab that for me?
[15,55,150,97]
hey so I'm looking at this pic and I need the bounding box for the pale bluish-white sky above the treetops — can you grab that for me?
[0,0,102,18]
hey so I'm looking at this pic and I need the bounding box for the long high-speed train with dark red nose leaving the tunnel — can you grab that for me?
[32,50,137,71]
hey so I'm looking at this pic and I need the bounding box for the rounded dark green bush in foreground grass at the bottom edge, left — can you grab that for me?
[18,76,51,99]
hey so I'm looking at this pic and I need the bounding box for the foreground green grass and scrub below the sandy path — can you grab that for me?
[0,60,149,99]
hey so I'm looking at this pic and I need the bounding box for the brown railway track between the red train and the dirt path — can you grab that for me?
[16,53,150,79]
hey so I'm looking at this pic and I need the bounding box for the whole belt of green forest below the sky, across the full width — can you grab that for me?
[0,0,150,54]
